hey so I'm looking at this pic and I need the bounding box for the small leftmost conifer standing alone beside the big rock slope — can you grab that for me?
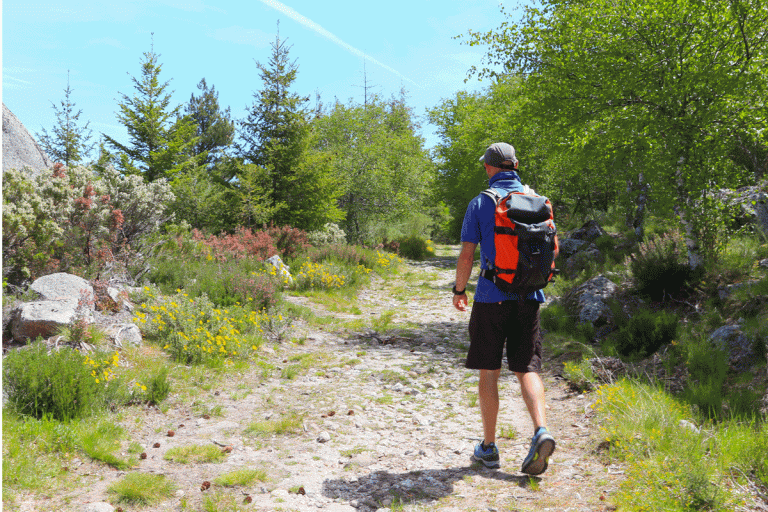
[37,71,96,167]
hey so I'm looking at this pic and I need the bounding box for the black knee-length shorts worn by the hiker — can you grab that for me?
[466,300,541,373]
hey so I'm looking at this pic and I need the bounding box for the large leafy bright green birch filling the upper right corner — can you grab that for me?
[468,0,768,266]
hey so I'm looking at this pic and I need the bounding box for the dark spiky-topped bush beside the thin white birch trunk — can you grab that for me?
[625,232,693,300]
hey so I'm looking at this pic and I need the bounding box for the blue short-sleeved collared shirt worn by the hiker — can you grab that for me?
[461,171,545,302]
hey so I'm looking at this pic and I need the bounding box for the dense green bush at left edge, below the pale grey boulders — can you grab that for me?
[3,340,117,421]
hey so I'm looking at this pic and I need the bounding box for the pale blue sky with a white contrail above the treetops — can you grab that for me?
[2,0,512,154]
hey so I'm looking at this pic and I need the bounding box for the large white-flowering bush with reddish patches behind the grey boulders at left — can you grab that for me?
[3,164,172,284]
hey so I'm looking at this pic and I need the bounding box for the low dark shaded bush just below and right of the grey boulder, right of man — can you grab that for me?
[613,309,678,359]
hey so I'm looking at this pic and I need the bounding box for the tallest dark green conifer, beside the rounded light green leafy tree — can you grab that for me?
[238,23,309,224]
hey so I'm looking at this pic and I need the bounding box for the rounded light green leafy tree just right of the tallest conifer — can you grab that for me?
[314,91,434,241]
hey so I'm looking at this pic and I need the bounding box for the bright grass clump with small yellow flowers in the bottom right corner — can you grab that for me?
[595,380,768,512]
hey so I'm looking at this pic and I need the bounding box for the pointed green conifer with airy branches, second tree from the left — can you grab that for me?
[104,38,205,181]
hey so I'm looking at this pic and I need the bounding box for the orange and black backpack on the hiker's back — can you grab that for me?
[480,185,558,300]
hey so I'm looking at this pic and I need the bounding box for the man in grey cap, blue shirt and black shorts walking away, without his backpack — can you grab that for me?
[453,142,555,475]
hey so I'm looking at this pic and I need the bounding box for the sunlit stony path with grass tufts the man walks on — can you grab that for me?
[27,248,622,512]
